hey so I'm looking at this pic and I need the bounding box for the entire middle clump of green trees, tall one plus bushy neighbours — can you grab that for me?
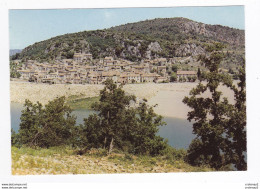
[81,80,167,155]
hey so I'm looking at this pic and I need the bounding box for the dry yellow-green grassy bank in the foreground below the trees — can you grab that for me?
[12,147,213,175]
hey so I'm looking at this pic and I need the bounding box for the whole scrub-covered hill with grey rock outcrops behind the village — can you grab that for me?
[13,18,245,68]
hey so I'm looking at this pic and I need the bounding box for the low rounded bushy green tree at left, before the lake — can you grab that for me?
[19,97,76,148]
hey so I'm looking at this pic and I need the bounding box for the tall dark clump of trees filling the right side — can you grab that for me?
[183,44,246,170]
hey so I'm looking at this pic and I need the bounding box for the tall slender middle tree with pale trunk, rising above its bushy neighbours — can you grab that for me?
[93,80,135,153]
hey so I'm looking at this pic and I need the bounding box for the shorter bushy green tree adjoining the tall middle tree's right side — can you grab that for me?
[126,99,167,155]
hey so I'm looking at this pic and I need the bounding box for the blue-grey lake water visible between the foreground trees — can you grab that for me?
[11,103,195,149]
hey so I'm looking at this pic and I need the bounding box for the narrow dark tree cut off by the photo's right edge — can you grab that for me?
[225,66,247,170]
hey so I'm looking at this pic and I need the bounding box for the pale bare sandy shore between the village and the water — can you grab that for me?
[10,81,236,119]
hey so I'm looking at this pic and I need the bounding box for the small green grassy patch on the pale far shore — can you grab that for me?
[66,95,100,110]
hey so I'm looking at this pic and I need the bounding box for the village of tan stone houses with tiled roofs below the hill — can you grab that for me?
[10,53,197,84]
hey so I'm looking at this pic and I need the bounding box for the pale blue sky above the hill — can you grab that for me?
[9,6,245,49]
